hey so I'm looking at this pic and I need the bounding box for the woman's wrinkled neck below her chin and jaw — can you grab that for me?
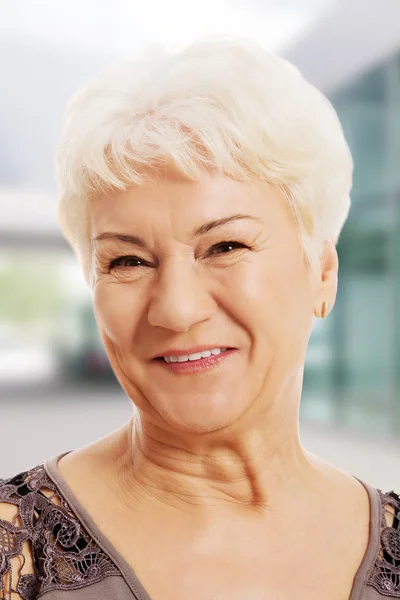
[113,394,323,514]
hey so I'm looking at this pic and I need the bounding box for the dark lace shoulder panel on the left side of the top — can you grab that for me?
[0,465,121,600]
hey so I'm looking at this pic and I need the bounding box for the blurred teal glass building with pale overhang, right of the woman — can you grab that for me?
[286,0,400,436]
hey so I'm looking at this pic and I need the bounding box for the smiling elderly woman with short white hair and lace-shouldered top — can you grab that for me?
[0,36,400,600]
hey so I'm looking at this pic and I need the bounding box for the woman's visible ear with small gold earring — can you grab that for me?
[314,241,339,319]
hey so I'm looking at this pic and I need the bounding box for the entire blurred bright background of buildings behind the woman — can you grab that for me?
[0,0,400,489]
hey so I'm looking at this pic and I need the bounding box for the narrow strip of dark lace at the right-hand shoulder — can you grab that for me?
[367,490,400,598]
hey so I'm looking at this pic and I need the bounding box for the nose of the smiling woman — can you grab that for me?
[148,260,218,332]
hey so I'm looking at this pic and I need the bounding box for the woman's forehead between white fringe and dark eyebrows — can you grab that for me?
[90,171,287,234]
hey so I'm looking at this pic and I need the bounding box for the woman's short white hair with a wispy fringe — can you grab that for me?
[56,36,353,282]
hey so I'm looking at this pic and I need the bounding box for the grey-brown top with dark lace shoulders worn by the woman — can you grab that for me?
[0,454,400,600]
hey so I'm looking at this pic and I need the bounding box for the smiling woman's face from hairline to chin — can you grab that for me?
[91,171,332,432]
